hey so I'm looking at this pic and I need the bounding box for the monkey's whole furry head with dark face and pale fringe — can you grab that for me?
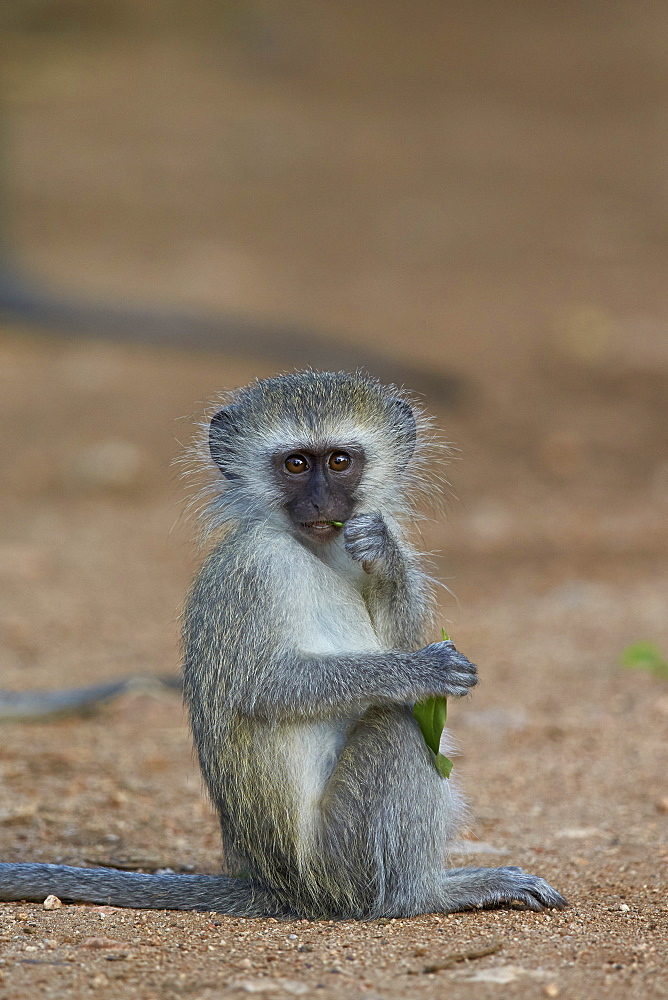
[209,371,430,542]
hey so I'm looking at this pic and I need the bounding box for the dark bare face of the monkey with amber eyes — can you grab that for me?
[273,445,364,542]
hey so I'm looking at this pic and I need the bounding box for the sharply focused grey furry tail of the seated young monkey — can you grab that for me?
[0,863,290,917]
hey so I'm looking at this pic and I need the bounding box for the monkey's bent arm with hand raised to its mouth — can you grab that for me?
[344,513,433,650]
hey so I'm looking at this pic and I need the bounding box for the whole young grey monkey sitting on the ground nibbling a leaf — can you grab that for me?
[0,371,565,919]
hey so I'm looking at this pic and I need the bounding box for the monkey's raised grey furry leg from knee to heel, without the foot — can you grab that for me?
[319,706,462,918]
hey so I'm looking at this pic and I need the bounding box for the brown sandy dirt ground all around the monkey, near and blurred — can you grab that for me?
[0,2,668,1000]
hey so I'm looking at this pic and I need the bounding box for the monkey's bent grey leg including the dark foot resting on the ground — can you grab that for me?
[314,709,565,917]
